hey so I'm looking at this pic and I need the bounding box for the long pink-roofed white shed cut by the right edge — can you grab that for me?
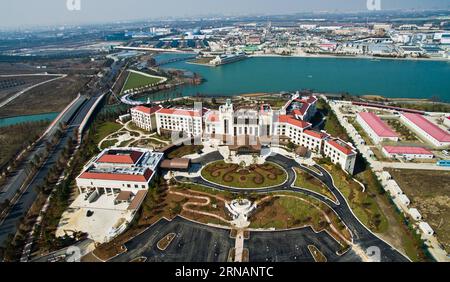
[400,113,450,147]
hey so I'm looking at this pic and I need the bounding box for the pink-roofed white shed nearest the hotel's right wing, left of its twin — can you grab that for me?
[356,112,398,144]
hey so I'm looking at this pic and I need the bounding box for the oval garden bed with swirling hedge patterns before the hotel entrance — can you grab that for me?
[202,161,287,188]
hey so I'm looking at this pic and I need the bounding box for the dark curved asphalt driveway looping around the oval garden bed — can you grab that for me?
[176,152,410,262]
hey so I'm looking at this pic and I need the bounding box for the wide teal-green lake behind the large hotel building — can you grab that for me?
[156,55,450,102]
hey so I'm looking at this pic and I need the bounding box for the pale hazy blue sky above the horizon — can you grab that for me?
[0,0,450,27]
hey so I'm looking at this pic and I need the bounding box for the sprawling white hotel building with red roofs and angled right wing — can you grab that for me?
[131,94,357,173]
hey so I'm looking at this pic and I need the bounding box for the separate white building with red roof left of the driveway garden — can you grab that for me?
[76,148,163,195]
